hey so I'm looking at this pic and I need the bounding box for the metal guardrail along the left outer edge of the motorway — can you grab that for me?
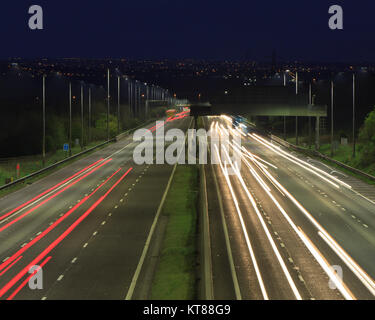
[0,119,160,191]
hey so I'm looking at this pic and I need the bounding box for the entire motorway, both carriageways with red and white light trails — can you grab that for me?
[0,112,375,300]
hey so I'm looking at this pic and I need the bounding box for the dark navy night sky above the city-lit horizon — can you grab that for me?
[0,0,375,62]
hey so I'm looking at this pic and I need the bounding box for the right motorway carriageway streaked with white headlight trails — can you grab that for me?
[205,116,375,300]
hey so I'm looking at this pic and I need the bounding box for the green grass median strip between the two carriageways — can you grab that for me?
[151,165,199,300]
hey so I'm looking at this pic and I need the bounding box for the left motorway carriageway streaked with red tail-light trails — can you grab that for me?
[0,117,191,300]
